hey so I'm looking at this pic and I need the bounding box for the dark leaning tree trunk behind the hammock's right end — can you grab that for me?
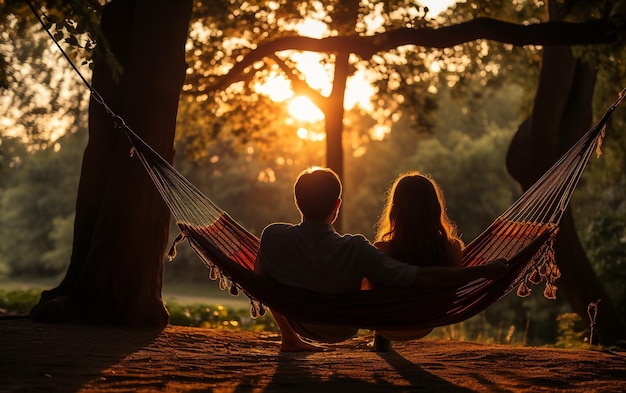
[507,43,626,345]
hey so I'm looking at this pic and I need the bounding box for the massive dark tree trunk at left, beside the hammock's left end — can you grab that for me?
[33,0,192,327]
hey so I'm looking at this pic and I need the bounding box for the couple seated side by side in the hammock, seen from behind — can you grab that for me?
[255,167,507,352]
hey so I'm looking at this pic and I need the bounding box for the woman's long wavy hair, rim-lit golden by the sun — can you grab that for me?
[376,171,463,266]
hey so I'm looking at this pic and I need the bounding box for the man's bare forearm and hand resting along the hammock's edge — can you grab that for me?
[413,259,508,288]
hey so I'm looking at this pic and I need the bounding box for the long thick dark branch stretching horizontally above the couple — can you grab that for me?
[210,18,618,91]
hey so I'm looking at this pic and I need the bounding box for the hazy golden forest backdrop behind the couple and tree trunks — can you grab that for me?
[0,0,626,344]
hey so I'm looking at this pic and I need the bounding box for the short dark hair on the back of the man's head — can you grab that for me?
[294,167,341,221]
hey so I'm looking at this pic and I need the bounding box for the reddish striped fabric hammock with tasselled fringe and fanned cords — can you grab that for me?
[124,89,626,330]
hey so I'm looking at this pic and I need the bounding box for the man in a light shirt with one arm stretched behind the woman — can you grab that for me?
[255,167,507,352]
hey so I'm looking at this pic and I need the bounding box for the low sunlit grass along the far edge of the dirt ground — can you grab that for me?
[0,278,589,348]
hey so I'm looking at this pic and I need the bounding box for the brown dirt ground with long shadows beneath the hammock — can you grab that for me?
[0,318,626,393]
